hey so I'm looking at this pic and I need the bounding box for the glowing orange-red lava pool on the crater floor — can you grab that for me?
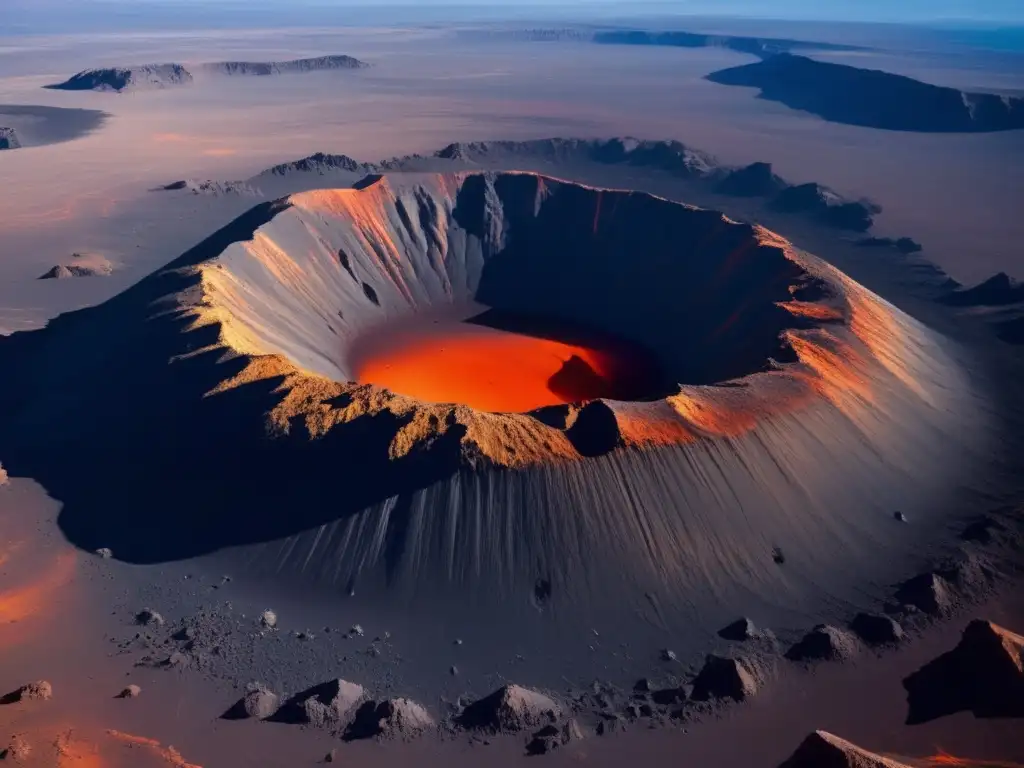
[356,323,651,413]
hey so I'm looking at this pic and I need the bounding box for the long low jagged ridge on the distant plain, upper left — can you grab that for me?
[45,55,370,92]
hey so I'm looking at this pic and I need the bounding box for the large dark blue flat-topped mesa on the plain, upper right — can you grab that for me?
[707,53,1024,133]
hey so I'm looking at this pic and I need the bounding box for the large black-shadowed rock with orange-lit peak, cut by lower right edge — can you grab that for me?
[903,620,1024,724]
